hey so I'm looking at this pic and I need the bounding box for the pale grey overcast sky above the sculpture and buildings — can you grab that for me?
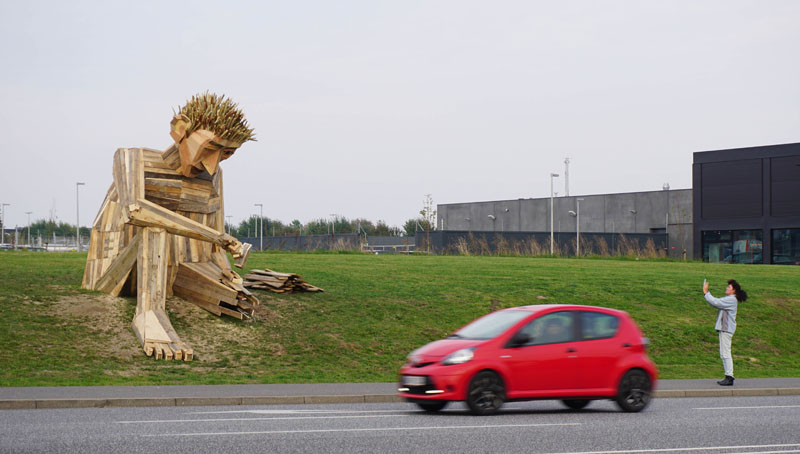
[0,0,800,231]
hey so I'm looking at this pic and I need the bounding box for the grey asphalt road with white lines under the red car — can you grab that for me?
[0,396,800,454]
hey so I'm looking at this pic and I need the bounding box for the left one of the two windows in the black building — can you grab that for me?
[703,230,764,263]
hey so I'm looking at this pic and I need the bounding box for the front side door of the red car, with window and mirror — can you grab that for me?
[501,311,577,393]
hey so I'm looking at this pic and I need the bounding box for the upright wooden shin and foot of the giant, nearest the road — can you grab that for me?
[133,227,193,361]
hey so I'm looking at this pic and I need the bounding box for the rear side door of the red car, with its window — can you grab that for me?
[575,311,625,390]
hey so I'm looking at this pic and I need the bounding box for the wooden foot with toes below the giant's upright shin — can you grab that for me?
[133,309,194,361]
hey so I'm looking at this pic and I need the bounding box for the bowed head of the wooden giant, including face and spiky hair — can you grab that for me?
[169,92,256,177]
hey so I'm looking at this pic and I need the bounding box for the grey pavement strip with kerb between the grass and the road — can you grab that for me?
[0,388,800,410]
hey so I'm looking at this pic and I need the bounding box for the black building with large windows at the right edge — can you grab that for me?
[692,143,800,265]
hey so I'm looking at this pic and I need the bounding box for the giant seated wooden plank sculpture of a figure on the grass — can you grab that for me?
[83,93,258,361]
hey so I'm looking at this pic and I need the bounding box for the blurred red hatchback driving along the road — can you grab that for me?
[398,305,658,415]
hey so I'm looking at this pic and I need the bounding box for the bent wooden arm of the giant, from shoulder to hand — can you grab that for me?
[114,148,242,258]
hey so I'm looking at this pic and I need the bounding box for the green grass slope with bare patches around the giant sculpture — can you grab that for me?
[0,252,800,386]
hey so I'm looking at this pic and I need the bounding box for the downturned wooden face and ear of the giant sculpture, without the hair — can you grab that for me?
[170,116,240,178]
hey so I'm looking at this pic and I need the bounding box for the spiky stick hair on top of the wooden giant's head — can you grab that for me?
[178,92,256,144]
